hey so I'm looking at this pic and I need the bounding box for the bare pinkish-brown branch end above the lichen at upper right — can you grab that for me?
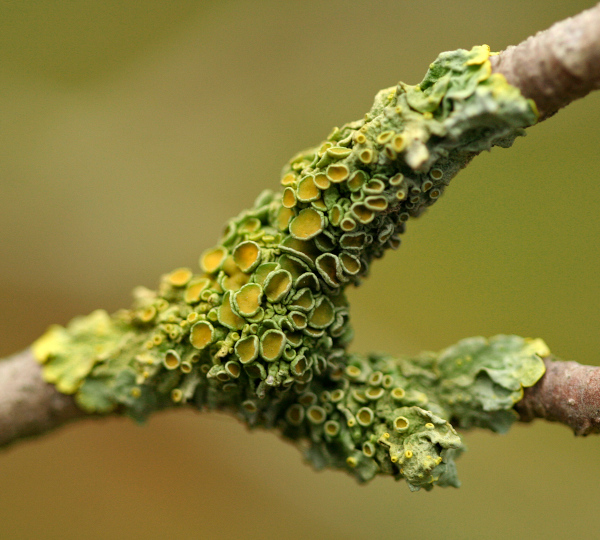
[490,4,600,121]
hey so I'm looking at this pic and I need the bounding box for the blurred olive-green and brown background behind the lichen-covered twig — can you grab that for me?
[0,0,600,539]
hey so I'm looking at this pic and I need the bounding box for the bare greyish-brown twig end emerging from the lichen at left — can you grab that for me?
[0,349,85,448]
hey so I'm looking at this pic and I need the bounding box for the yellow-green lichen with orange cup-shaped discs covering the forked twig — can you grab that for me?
[34,46,548,490]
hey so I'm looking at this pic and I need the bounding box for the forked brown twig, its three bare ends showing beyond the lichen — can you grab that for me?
[0,4,600,456]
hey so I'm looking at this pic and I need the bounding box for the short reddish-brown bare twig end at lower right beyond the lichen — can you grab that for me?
[515,358,600,435]
